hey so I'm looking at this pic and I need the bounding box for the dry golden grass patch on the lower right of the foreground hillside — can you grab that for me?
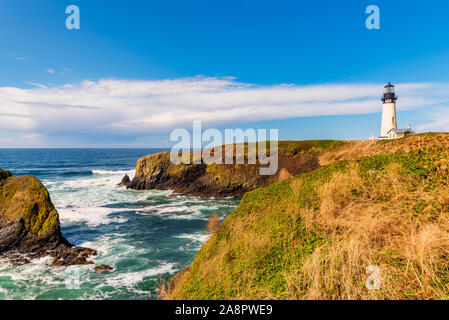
[287,164,449,299]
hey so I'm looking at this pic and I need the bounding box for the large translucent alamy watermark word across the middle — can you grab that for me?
[170,121,278,175]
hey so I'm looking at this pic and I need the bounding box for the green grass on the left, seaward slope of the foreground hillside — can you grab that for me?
[169,159,345,299]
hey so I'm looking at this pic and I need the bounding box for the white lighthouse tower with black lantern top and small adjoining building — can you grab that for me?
[379,82,414,140]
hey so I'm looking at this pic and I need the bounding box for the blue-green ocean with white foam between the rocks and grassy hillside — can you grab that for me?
[0,149,238,299]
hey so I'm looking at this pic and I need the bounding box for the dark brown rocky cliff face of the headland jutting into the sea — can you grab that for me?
[126,141,343,197]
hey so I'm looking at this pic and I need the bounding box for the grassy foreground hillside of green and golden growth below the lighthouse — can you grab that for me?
[166,134,449,299]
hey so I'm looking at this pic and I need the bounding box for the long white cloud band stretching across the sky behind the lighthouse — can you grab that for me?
[0,77,449,146]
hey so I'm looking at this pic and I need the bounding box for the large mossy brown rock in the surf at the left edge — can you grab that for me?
[0,169,96,266]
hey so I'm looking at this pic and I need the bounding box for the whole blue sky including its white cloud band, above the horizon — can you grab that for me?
[0,0,449,147]
